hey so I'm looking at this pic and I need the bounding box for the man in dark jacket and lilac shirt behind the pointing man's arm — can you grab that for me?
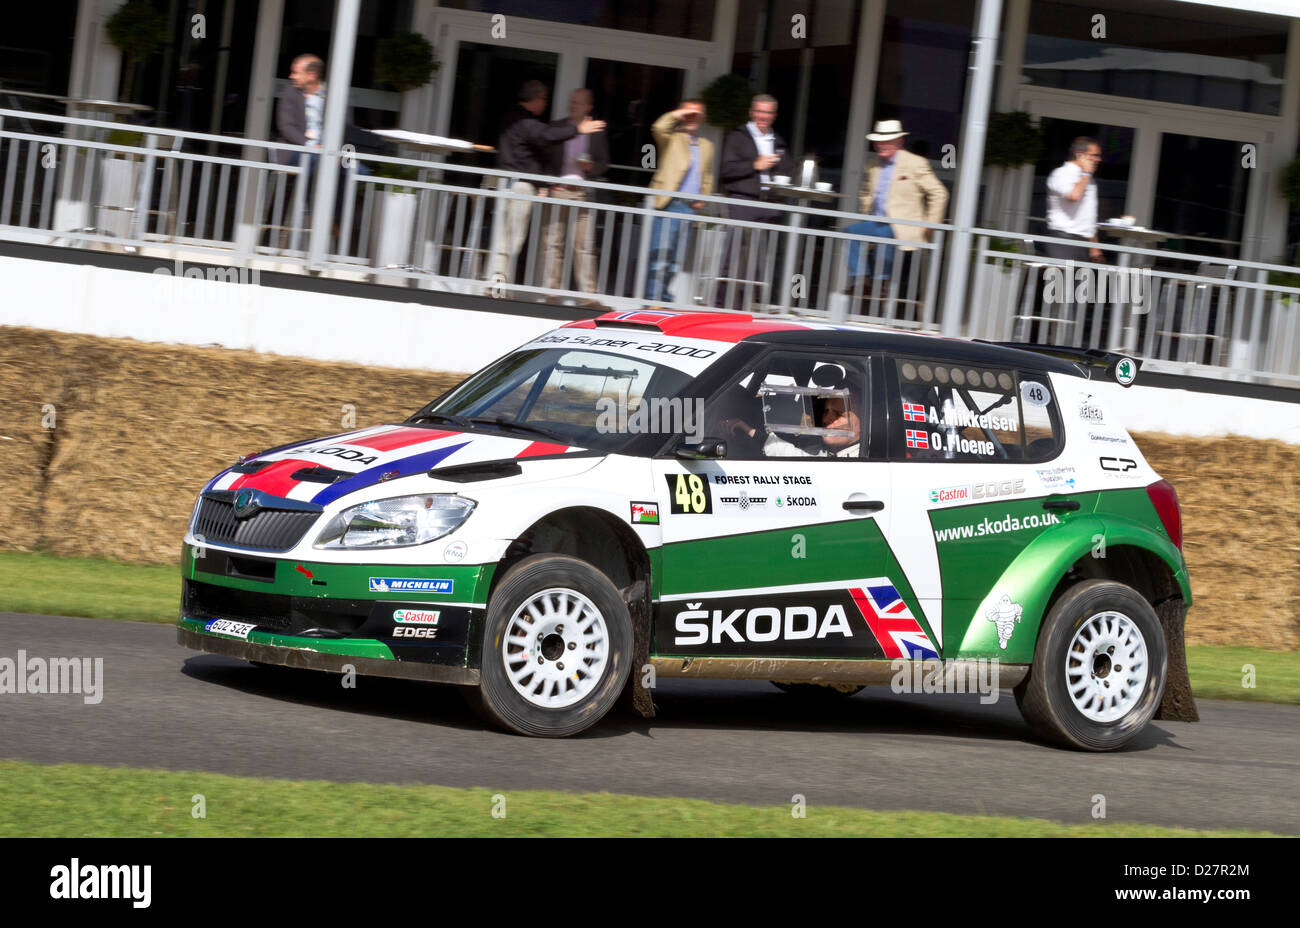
[545,87,610,305]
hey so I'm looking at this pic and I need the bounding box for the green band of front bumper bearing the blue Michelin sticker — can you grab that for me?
[181,545,497,604]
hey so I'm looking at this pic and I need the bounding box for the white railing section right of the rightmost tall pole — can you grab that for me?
[962,229,1300,385]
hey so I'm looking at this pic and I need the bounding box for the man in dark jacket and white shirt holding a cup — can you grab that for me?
[716,94,792,309]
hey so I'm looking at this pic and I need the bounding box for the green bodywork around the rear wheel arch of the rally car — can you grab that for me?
[932,487,1191,663]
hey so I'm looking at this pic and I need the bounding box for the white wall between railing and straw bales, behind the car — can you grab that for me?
[0,250,1300,445]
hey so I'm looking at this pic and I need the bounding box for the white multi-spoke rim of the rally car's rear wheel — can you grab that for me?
[1065,612,1151,723]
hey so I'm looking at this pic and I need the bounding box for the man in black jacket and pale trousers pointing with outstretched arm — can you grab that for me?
[488,81,605,288]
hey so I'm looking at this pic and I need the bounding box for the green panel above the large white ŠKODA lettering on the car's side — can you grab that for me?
[657,519,937,641]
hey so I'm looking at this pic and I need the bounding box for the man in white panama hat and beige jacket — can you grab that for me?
[845,120,948,292]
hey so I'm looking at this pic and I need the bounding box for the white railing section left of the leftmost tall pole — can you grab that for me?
[0,109,313,264]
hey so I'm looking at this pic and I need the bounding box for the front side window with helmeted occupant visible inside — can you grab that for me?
[705,351,870,460]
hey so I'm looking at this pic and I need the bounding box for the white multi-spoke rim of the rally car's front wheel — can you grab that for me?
[501,587,610,708]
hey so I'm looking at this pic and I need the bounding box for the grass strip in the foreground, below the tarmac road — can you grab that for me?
[0,760,1279,837]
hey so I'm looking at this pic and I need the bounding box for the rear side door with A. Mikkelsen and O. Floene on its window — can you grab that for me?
[887,357,1074,659]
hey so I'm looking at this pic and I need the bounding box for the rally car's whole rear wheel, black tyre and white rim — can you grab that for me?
[1015,580,1169,751]
